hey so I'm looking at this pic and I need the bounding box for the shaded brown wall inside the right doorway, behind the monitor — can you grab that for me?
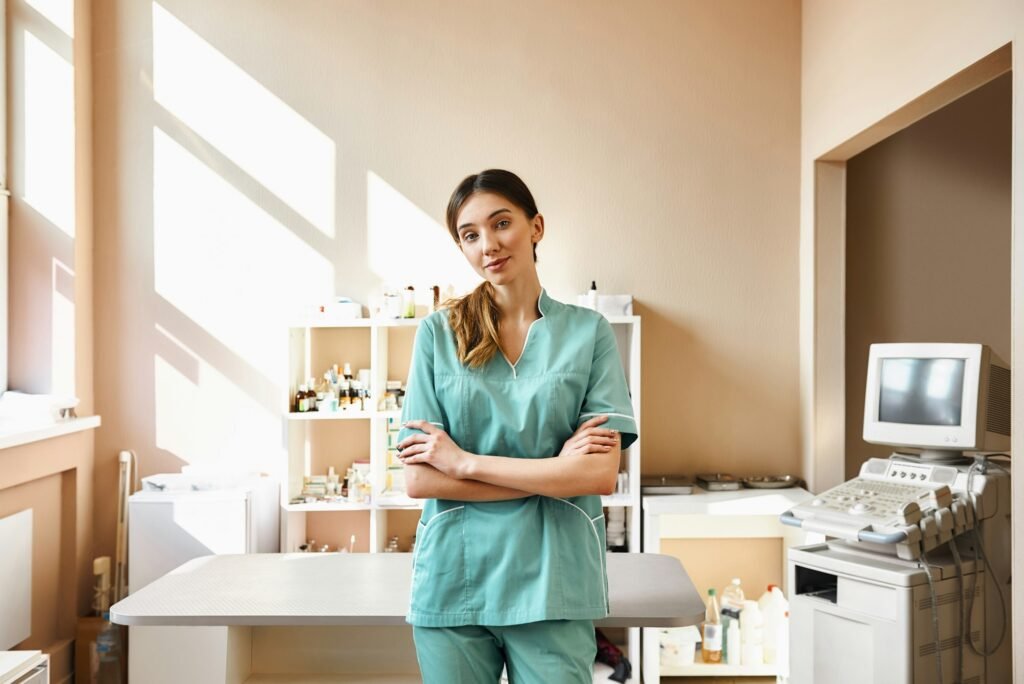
[846,74,1013,477]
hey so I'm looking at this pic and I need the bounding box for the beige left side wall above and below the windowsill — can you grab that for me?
[0,0,96,681]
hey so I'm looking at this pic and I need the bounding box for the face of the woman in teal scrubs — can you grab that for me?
[456,193,544,285]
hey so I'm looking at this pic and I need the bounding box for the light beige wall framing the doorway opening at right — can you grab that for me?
[800,0,1024,681]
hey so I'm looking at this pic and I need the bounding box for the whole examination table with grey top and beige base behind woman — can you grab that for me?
[111,553,705,684]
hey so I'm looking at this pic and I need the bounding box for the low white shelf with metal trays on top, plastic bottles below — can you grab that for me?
[643,487,817,684]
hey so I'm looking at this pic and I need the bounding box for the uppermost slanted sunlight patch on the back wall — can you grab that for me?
[153,3,336,237]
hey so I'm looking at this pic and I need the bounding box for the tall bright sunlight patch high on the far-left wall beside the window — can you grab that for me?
[22,31,75,238]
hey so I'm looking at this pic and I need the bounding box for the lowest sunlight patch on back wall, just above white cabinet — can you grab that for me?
[154,326,283,470]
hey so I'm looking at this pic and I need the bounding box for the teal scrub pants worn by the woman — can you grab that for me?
[413,619,597,684]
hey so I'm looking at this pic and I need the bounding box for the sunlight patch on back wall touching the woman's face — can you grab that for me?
[367,171,480,294]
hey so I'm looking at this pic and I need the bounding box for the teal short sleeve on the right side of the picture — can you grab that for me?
[577,316,640,450]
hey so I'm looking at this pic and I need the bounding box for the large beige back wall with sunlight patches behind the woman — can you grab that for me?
[93,0,800,548]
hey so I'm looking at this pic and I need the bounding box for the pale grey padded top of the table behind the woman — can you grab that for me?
[111,553,705,627]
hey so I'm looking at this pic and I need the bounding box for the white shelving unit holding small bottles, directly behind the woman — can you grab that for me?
[281,314,642,681]
